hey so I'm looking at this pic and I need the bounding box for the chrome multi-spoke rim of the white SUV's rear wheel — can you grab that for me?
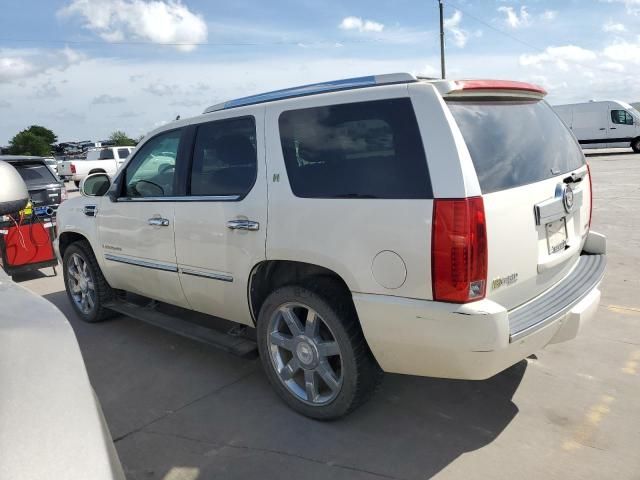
[267,303,343,406]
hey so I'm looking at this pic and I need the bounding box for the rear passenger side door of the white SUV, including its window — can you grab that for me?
[175,111,267,324]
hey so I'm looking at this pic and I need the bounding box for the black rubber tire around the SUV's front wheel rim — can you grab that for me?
[62,240,114,323]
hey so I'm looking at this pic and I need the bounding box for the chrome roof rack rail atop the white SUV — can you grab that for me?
[203,73,418,113]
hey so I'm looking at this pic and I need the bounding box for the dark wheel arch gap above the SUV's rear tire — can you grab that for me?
[247,260,355,325]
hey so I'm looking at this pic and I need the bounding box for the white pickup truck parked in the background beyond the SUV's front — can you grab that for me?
[58,147,135,187]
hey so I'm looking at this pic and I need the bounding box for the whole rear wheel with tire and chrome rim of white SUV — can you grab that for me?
[258,282,382,420]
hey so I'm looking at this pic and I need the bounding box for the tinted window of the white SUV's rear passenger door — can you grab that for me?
[189,117,258,199]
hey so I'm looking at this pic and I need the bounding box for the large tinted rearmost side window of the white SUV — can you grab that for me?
[279,98,433,199]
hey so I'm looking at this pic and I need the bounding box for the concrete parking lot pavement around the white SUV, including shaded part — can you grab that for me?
[17,150,640,480]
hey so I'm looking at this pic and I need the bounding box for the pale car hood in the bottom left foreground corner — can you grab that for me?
[0,270,124,480]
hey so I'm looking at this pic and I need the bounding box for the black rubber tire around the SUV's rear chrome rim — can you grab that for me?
[257,277,382,420]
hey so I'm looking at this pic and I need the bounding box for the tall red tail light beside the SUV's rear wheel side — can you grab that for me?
[431,197,487,303]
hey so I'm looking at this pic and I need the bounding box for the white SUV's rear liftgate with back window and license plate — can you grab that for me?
[447,98,590,308]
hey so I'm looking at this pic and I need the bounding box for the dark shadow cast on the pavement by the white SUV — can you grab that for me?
[46,291,527,480]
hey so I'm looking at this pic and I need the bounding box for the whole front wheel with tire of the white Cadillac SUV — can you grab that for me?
[62,241,113,323]
